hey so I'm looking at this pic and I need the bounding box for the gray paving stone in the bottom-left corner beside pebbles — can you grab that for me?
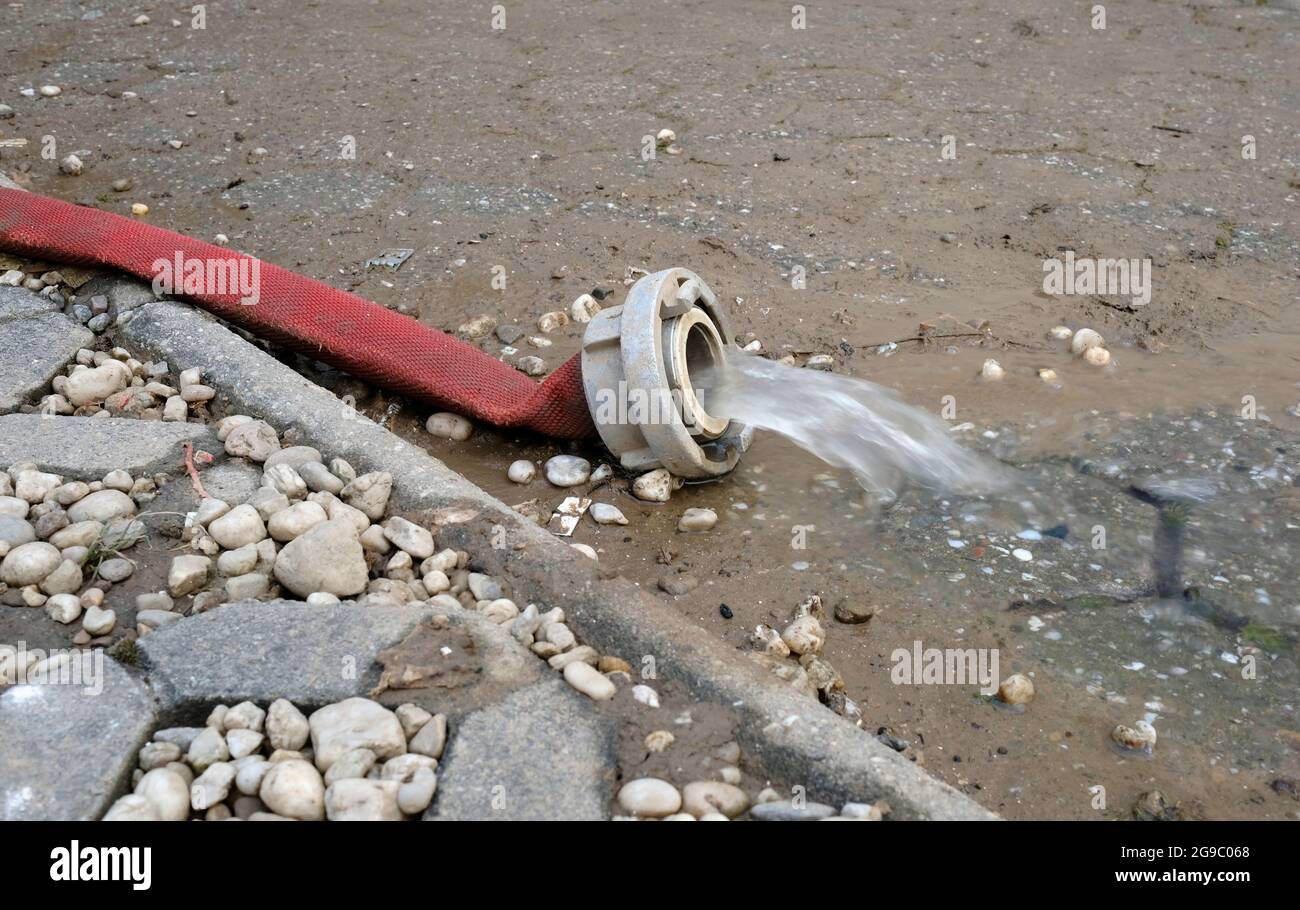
[0,650,157,820]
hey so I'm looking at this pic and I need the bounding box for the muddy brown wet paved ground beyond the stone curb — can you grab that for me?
[0,0,1300,819]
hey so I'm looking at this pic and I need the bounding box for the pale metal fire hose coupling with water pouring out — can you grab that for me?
[582,269,754,480]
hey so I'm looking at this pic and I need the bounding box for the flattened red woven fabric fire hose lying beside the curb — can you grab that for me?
[0,187,595,439]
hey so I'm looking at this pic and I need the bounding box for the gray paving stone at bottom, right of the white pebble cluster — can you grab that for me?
[425,676,615,822]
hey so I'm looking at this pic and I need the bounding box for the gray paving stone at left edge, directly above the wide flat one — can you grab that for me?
[0,308,95,413]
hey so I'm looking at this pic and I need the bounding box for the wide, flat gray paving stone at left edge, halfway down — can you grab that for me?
[0,413,225,480]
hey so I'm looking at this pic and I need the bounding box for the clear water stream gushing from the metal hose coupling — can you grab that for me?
[692,355,1011,501]
